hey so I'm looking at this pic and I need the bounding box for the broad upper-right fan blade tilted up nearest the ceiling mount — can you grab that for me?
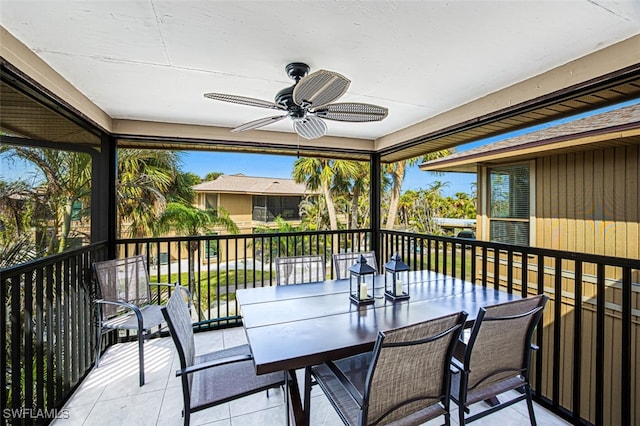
[293,70,351,108]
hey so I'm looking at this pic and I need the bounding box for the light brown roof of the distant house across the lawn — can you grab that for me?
[193,174,312,196]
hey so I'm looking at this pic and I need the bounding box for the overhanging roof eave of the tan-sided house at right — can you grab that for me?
[420,104,640,173]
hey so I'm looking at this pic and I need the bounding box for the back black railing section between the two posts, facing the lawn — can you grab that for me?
[116,230,371,330]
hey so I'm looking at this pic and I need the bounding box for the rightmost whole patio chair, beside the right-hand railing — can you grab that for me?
[451,295,548,425]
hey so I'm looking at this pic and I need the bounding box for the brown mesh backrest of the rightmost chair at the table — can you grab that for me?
[464,295,548,389]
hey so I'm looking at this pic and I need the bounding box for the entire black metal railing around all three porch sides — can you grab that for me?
[0,230,640,425]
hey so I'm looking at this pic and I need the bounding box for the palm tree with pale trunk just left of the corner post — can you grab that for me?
[292,157,357,230]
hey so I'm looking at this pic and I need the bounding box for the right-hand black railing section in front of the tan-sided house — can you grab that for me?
[380,231,640,425]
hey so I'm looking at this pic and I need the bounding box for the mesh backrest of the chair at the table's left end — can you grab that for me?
[161,285,196,392]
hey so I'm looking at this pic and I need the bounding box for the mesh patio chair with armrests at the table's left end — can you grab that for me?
[162,286,286,425]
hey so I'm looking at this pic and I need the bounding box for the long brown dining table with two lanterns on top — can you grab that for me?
[236,271,519,423]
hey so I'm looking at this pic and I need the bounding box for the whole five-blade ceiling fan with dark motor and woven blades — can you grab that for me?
[204,62,388,139]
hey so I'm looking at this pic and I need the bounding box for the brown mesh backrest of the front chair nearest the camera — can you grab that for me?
[360,312,467,424]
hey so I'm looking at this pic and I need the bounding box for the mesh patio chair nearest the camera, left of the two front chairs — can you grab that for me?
[311,312,467,426]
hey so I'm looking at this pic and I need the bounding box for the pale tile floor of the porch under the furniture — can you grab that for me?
[53,327,569,426]
